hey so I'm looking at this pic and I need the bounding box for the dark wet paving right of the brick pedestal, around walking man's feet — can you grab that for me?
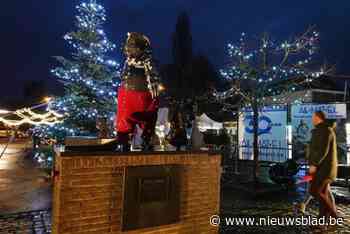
[221,184,350,234]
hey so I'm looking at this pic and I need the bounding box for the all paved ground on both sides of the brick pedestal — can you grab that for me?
[0,141,350,234]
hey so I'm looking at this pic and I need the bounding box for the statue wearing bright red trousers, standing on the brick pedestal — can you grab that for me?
[116,32,159,152]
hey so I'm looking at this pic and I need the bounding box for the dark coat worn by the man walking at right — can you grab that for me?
[309,123,338,184]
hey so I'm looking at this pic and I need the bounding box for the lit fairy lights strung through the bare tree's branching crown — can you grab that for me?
[215,27,327,105]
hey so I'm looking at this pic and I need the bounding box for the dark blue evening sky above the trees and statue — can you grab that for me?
[0,0,350,97]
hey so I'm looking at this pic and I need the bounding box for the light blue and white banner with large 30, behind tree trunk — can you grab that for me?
[238,106,288,162]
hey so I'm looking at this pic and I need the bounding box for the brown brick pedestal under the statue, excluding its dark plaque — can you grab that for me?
[52,152,221,234]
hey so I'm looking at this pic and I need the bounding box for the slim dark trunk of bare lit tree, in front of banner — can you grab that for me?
[252,100,259,184]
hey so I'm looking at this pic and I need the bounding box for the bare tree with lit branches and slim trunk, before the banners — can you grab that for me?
[216,27,332,182]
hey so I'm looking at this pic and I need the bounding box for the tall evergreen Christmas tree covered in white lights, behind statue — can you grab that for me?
[35,0,119,139]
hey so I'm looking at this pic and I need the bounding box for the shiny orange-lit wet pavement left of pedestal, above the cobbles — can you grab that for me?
[0,139,51,214]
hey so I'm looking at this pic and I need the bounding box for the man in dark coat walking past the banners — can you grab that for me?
[309,111,338,217]
